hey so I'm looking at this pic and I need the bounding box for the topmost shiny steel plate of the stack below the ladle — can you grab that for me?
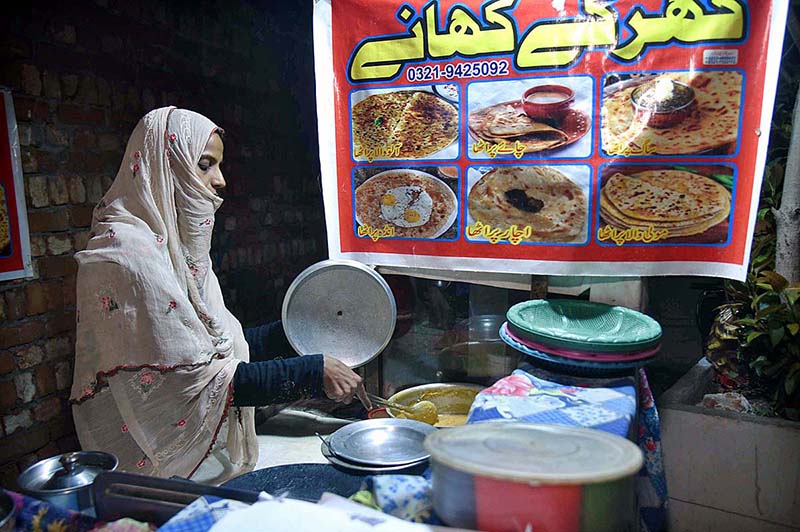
[328,418,436,466]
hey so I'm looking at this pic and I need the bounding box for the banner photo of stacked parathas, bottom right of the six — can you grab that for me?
[600,165,733,243]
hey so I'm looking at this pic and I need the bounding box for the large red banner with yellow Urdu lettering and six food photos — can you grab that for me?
[314,0,787,279]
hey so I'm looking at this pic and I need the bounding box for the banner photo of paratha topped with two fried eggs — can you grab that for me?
[355,168,458,239]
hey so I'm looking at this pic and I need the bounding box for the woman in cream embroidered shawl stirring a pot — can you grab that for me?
[71,108,363,477]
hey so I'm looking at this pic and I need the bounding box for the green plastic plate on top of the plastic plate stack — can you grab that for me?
[506,299,661,353]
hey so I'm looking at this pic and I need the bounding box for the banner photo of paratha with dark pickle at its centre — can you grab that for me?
[467,166,589,243]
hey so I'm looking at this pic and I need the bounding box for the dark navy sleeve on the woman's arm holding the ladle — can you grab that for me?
[233,355,324,406]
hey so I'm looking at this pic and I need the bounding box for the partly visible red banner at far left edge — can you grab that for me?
[0,90,33,281]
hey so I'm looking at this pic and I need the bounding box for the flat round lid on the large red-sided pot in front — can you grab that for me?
[425,422,644,484]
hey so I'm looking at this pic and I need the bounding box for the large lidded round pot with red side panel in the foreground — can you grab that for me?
[425,421,643,532]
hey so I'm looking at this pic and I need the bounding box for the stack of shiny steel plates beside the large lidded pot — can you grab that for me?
[322,418,436,474]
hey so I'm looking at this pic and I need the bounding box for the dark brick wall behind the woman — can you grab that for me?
[0,0,325,487]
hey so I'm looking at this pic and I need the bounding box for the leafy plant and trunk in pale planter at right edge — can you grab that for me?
[659,47,800,531]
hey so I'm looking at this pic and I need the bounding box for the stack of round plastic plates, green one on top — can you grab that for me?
[500,299,661,376]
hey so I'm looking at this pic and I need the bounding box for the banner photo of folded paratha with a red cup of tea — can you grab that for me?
[467,77,593,159]
